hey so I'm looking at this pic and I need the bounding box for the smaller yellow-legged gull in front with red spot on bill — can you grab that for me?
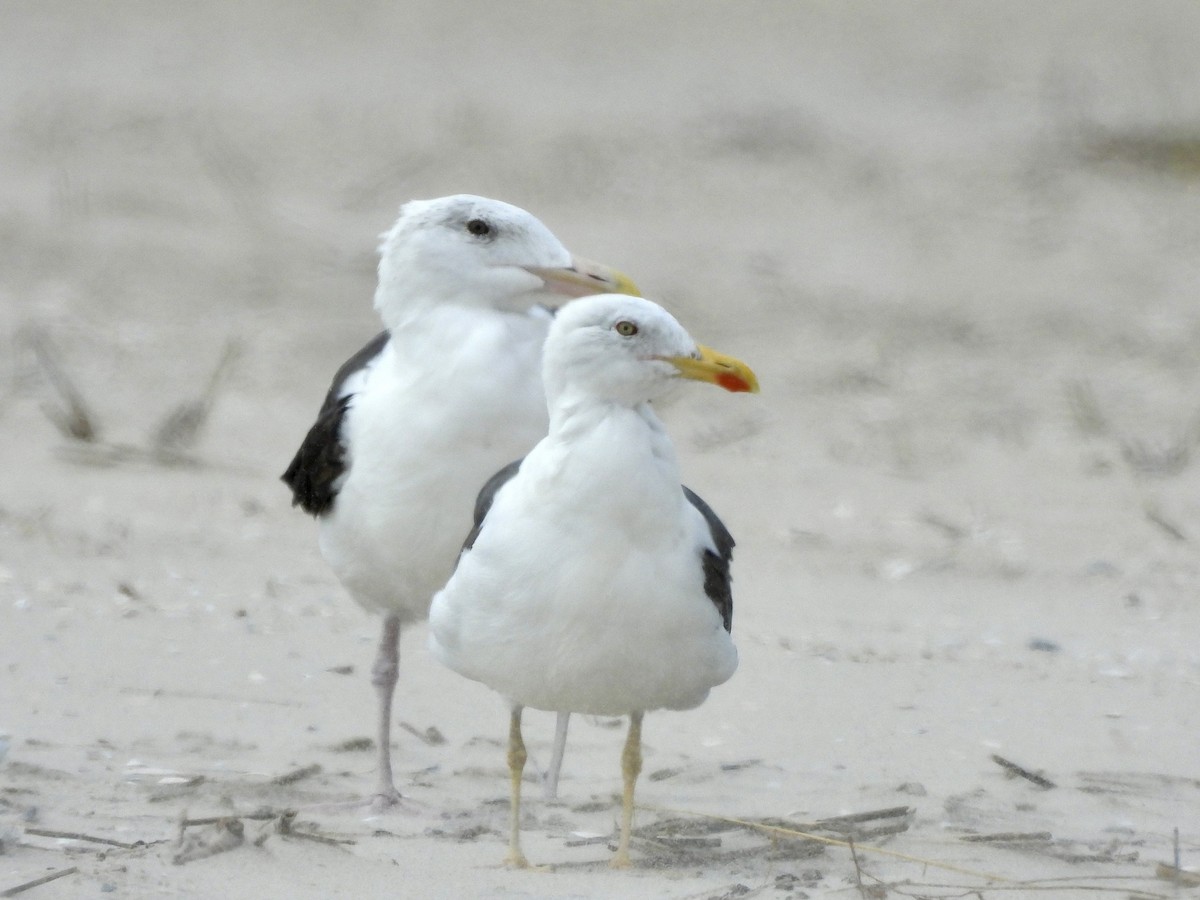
[430,295,758,868]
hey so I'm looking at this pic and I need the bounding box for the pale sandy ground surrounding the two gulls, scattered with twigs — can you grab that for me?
[0,0,1200,900]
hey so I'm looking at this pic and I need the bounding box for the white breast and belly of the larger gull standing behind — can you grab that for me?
[320,308,546,619]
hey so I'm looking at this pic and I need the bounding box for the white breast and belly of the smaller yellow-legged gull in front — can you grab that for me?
[431,410,737,715]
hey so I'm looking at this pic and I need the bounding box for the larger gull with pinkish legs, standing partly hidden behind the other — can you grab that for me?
[283,194,637,809]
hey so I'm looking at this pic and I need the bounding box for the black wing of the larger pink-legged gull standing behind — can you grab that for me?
[283,331,390,516]
